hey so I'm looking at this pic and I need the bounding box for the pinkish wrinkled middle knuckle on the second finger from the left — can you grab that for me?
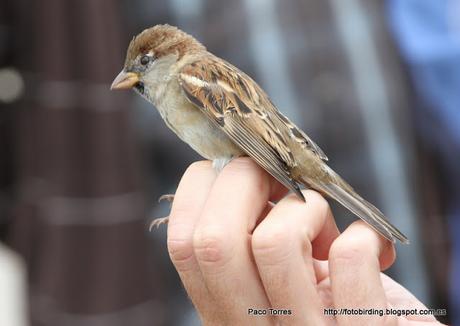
[193,227,233,267]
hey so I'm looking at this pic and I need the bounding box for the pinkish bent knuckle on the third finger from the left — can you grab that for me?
[251,222,292,264]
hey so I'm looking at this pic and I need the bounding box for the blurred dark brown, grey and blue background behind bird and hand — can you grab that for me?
[0,0,460,326]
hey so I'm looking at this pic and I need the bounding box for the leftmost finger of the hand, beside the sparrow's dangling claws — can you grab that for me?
[168,161,216,312]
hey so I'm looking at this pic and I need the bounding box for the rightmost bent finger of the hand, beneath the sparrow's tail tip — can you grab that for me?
[329,221,396,325]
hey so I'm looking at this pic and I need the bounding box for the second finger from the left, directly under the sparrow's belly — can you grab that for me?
[194,158,279,323]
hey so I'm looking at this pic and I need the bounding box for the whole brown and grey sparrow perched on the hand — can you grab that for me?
[111,25,409,243]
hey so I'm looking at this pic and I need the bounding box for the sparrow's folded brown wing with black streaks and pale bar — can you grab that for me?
[179,56,327,198]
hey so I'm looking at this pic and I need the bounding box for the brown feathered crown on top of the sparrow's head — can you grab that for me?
[125,24,206,67]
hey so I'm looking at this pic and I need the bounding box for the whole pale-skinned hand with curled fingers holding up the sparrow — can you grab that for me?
[168,158,439,325]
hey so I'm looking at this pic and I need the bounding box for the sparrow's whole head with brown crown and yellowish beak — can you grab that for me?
[110,25,205,97]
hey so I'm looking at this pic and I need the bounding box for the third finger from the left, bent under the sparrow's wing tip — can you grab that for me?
[252,190,333,325]
